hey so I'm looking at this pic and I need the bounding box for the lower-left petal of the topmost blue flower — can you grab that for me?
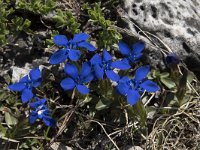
[50,49,68,65]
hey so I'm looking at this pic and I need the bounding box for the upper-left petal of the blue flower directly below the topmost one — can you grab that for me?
[64,63,78,79]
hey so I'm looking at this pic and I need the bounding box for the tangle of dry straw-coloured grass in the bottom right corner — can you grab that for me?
[147,98,200,150]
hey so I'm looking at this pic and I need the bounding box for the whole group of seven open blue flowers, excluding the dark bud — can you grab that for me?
[8,33,159,126]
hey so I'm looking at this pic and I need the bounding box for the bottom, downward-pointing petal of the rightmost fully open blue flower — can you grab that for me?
[127,90,140,105]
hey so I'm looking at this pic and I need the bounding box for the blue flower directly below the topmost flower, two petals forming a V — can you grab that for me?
[60,62,94,94]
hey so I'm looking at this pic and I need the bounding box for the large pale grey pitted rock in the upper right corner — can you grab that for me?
[120,0,200,73]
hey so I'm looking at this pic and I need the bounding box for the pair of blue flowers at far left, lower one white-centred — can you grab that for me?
[8,68,56,127]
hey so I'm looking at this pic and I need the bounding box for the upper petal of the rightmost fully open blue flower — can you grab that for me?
[135,66,150,81]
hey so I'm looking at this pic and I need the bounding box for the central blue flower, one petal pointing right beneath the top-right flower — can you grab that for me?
[90,50,130,81]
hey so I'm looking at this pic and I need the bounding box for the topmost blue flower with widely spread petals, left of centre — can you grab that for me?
[50,33,96,64]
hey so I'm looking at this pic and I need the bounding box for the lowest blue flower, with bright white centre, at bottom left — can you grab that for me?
[29,97,56,127]
